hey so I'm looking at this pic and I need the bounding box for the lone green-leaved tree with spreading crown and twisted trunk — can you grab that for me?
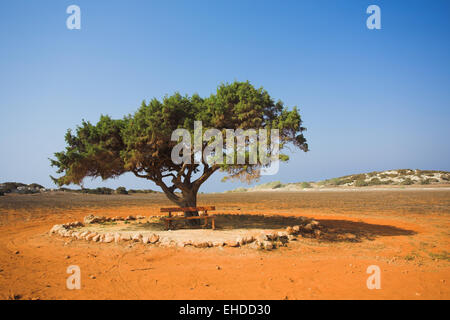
[50,82,308,216]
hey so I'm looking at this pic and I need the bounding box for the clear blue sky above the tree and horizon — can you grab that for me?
[0,0,450,192]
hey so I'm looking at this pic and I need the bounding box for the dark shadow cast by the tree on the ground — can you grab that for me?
[134,214,417,242]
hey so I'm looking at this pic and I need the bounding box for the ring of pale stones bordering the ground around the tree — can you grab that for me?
[49,215,322,250]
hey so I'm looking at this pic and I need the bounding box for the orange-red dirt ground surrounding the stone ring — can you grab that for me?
[0,188,450,299]
